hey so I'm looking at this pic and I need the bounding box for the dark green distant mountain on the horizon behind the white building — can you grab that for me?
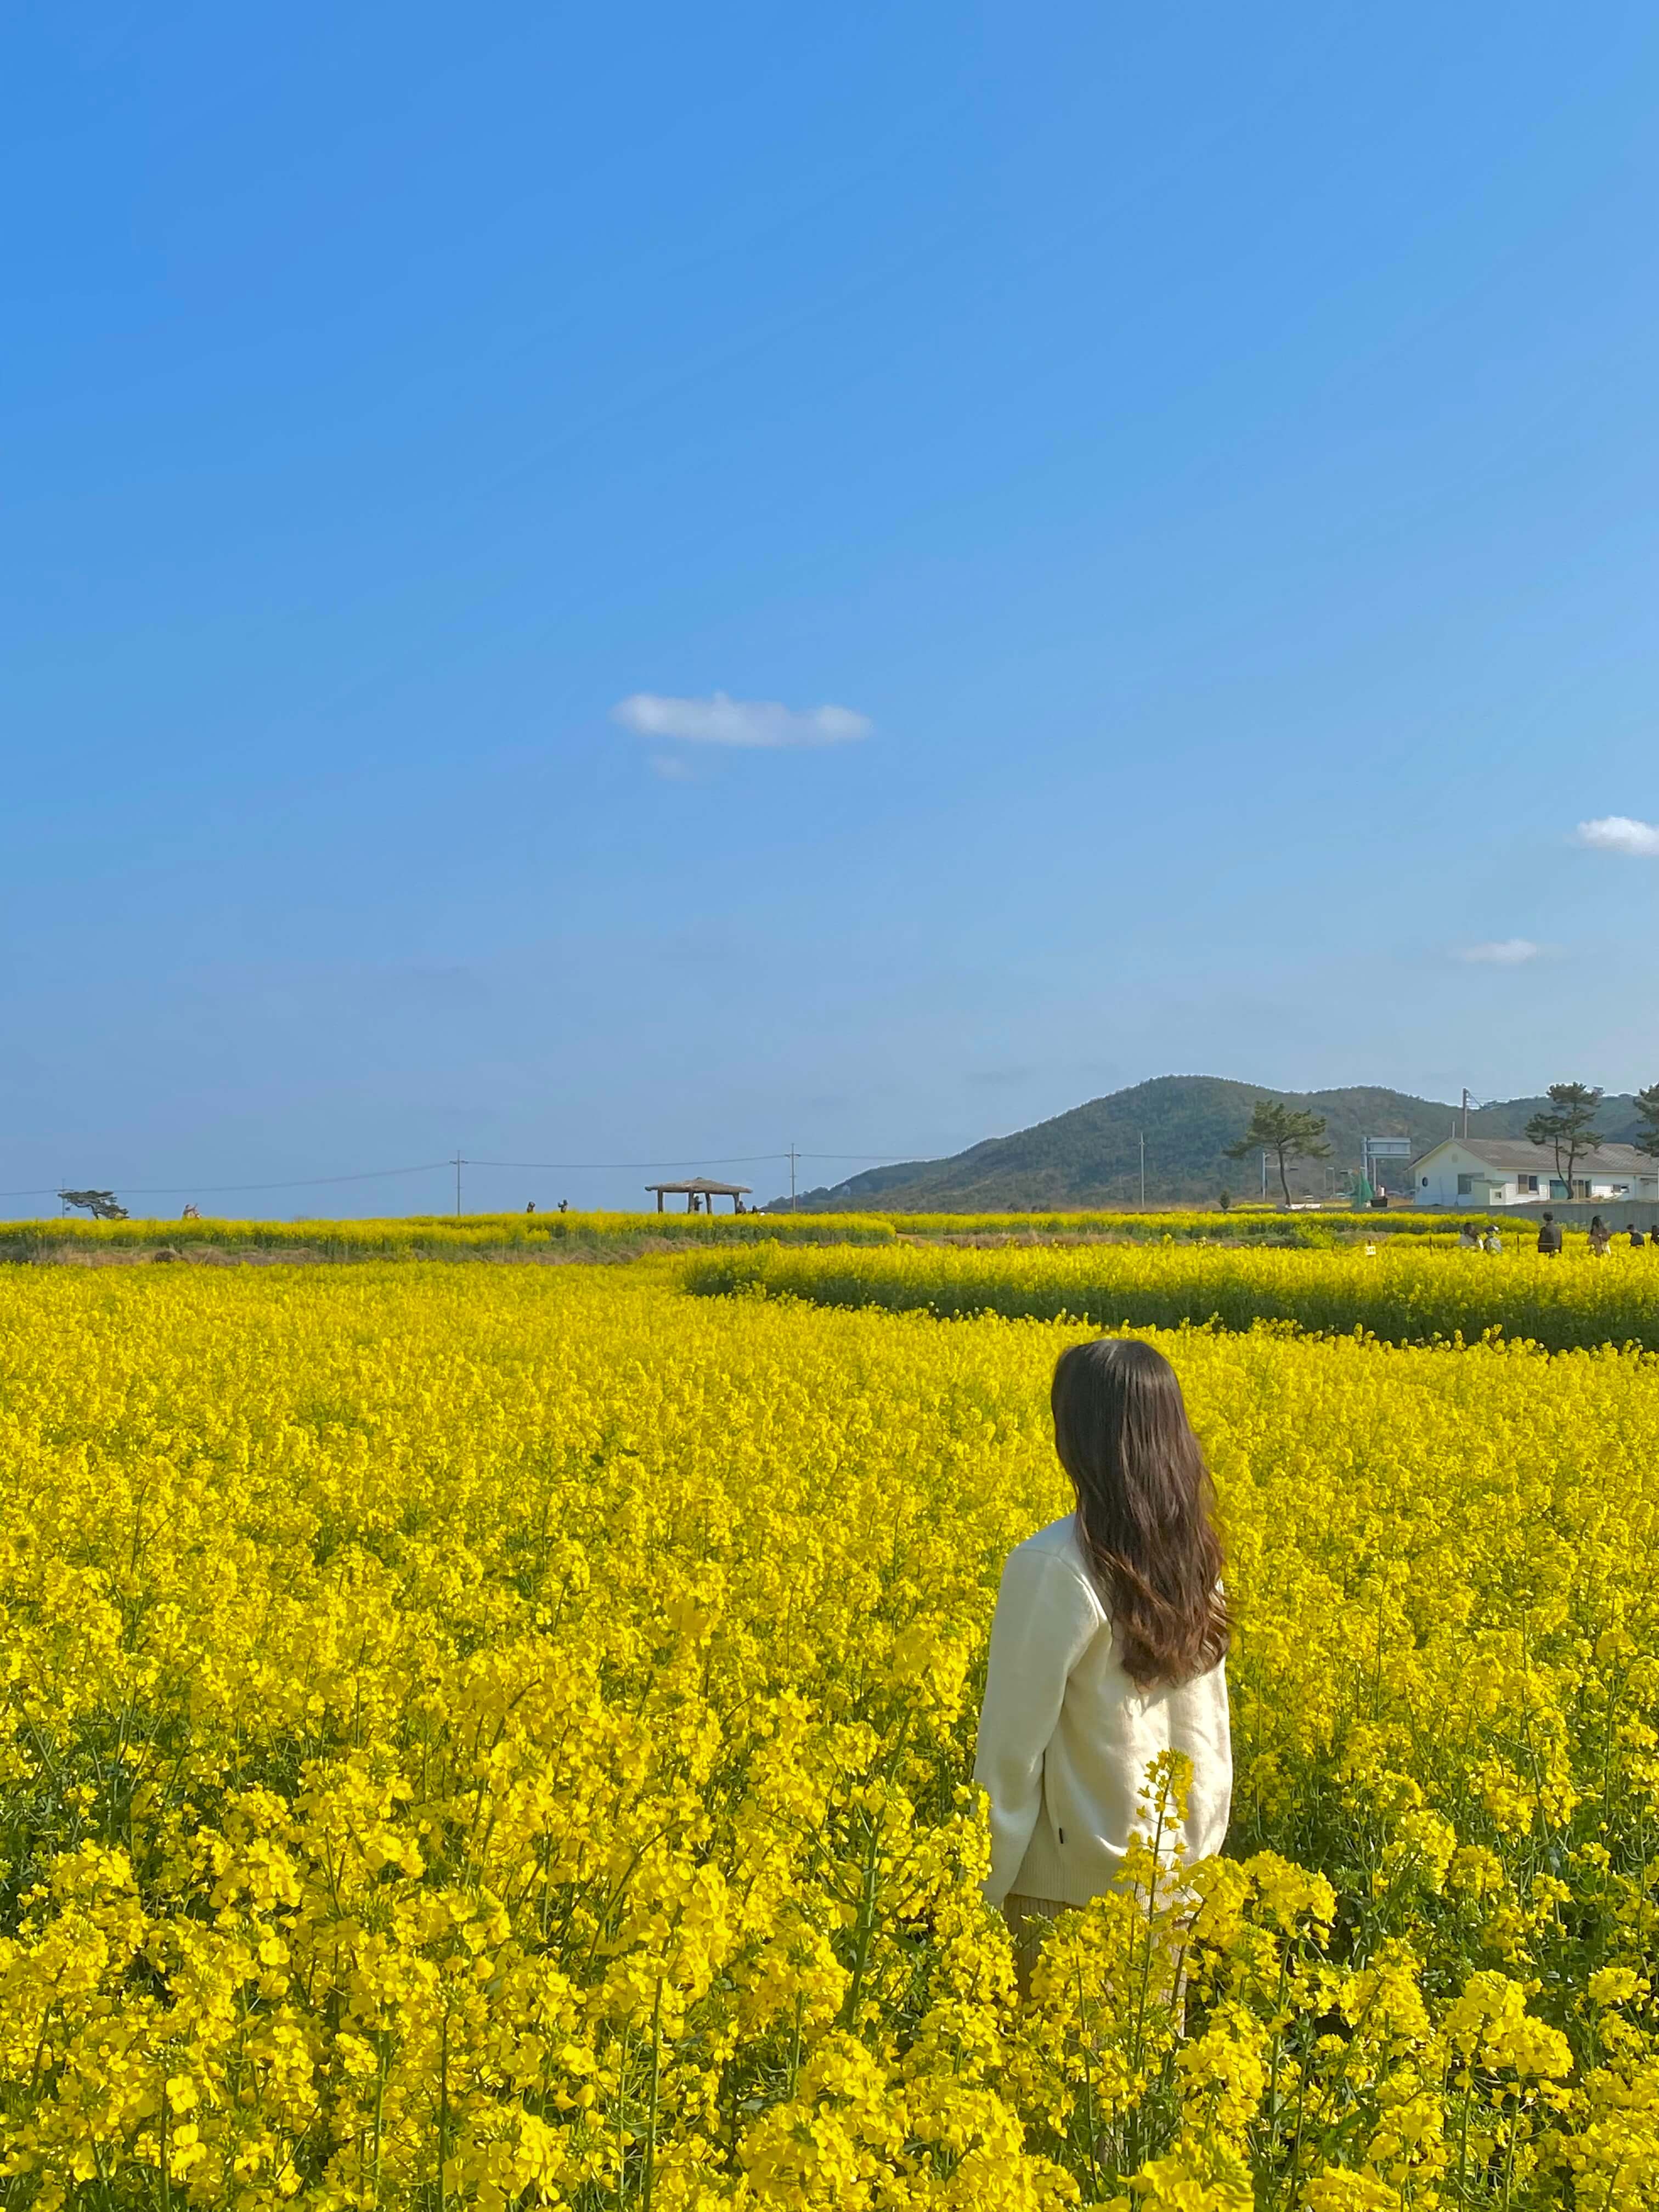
[781,1075,1641,1215]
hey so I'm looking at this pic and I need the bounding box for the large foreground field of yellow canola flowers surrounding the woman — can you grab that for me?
[0,1261,1659,2212]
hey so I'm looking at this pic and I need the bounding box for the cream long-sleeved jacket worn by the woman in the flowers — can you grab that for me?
[973,1515,1232,1905]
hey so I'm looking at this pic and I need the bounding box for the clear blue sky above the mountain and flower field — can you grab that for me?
[0,0,1659,1215]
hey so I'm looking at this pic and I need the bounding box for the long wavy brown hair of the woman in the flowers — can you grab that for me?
[1053,1336,1228,1688]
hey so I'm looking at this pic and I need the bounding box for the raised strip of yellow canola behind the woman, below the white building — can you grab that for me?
[692,1237,1659,1352]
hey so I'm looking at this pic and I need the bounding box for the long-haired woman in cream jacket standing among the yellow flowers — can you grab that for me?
[973,1336,1232,1993]
